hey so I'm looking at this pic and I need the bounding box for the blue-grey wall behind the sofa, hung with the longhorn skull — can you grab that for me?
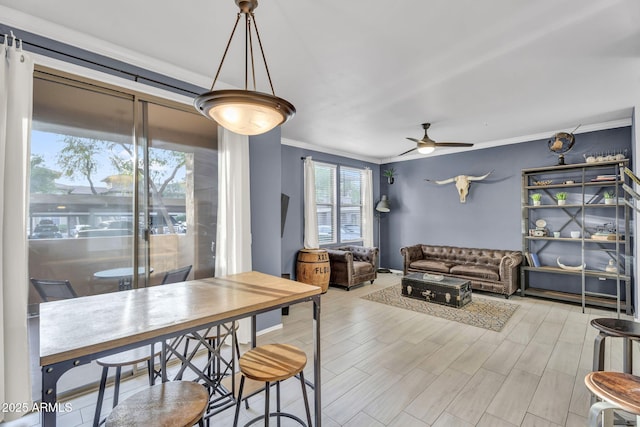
[380,127,631,270]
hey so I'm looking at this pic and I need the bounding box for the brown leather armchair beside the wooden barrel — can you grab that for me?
[327,245,378,290]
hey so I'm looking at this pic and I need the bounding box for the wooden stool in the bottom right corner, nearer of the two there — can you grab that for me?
[584,371,640,427]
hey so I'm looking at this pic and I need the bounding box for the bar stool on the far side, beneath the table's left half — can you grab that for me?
[93,346,160,427]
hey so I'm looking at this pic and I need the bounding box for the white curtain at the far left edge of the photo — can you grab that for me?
[0,36,33,421]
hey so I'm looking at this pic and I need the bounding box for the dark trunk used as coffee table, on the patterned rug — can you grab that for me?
[402,273,471,308]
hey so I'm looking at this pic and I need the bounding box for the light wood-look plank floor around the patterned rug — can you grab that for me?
[4,274,638,427]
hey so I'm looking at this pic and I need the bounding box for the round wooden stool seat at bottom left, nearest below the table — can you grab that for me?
[105,381,209,427]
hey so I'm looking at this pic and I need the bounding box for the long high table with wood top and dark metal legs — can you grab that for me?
[40,272,322,427]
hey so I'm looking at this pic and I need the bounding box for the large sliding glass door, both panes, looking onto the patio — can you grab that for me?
[25,70,218,397]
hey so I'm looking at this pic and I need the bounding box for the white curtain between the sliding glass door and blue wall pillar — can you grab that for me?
[216,126,251,343]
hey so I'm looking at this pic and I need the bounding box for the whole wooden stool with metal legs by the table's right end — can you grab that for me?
[233,344,311,427]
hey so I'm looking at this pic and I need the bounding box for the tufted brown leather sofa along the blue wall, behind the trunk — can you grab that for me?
[400,244,522,298]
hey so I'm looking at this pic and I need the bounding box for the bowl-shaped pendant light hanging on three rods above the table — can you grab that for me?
[194,0,296,135]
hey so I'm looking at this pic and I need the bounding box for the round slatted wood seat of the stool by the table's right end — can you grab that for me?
[238,344,307,382]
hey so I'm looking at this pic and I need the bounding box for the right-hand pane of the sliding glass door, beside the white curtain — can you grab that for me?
[139,102,218,285]
